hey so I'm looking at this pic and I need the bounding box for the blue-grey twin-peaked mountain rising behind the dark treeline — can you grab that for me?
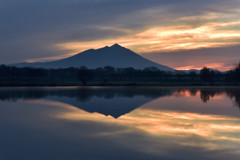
[11,44,174,71]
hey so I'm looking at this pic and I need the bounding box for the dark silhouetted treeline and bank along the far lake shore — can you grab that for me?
[0,63,240,87]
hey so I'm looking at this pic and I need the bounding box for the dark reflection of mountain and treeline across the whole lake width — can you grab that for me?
[0,87,240,118]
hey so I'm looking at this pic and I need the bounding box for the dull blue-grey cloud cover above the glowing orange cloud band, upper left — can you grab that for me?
[0,0,237,63]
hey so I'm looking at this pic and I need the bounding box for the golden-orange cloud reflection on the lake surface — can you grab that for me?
[56,102,240,156]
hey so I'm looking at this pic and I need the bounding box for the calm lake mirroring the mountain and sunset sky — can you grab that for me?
[0,87,240,160]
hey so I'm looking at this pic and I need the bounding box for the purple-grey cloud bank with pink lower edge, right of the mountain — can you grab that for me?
[143,45,240,71]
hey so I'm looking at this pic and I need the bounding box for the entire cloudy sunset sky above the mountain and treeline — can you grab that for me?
[0,0,240,71]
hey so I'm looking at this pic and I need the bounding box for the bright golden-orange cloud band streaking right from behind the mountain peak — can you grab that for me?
[57,18,240,53]
